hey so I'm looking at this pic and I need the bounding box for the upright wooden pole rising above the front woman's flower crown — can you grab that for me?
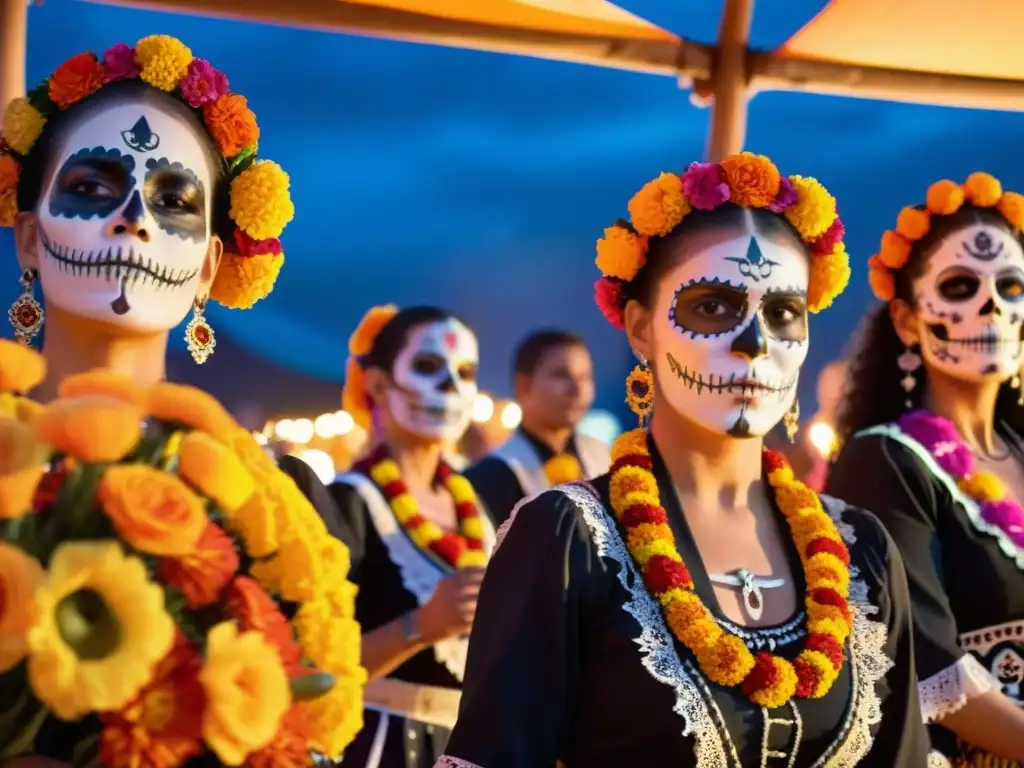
[708,0,754,163]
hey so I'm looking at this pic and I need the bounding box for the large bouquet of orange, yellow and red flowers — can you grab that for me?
[0,342,366,768]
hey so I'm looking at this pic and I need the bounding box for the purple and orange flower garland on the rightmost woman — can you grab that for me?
[897,409,1024,548]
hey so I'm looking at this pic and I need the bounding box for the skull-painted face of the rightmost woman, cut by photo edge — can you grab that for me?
[913,224,1024,381]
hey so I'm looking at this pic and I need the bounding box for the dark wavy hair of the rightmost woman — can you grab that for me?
[836,203,1024,443]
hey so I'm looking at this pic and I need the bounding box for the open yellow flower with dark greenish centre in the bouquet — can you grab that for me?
[28,541,174,720]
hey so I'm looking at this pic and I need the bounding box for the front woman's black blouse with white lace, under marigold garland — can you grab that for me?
[438,444,928,768]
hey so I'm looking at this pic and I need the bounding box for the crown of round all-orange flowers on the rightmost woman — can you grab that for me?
[867,172,1024,301]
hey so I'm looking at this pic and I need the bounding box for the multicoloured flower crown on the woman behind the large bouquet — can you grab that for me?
[0,35,295,309]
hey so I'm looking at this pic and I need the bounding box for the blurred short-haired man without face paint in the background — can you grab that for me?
[466,331,611,523]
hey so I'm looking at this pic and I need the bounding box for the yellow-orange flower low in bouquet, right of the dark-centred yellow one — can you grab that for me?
[199,622,292,766]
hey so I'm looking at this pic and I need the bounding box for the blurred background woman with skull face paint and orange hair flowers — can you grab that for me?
[331,306,495,768]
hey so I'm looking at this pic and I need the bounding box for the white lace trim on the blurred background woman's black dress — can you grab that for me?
[335,472,496,683]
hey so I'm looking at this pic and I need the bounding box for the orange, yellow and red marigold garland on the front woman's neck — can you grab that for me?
[609,429,853,709]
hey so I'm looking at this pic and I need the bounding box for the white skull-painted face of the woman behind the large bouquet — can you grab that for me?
[38,98,215,333]
